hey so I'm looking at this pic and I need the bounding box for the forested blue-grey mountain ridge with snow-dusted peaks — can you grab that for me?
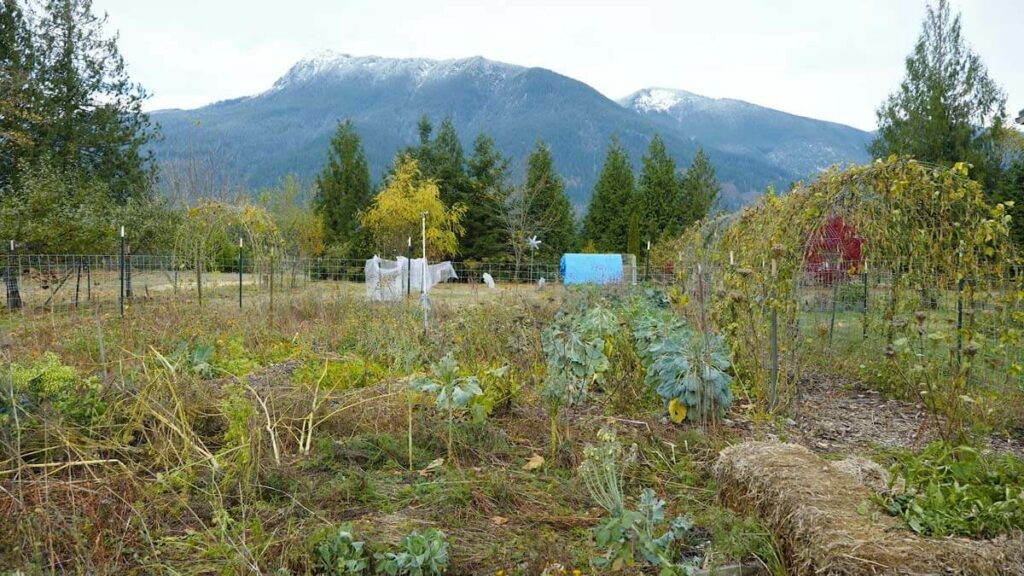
[151,51,868,208]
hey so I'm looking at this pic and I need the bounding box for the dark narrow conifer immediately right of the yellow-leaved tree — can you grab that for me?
[461,132,509,260]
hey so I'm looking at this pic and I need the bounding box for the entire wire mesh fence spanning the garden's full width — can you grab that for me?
[0,249,1024,414]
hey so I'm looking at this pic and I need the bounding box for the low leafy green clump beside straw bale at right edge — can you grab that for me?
[883,443,1024,538]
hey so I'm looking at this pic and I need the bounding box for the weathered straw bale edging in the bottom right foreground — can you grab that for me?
[714,442,1024,576]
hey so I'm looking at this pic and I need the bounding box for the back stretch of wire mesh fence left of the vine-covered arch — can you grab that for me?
[2,252,674,314]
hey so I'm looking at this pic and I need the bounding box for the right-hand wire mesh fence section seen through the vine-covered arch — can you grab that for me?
[795,262,1024,389]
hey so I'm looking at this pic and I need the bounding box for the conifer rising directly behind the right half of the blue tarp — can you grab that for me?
[583,136,635,252]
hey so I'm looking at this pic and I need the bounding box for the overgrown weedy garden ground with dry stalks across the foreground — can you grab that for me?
[0,290,782,574]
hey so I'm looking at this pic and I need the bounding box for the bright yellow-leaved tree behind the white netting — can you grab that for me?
[361,156,466,259]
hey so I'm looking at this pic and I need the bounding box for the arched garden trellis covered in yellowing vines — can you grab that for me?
[682,157,1024,428]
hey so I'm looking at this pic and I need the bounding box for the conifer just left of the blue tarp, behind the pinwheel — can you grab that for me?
[525,141,575,261]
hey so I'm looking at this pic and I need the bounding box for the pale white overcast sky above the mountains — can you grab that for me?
[94,0,1024,129]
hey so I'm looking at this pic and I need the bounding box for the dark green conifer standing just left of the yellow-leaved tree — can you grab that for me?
[313,120,372,246]
